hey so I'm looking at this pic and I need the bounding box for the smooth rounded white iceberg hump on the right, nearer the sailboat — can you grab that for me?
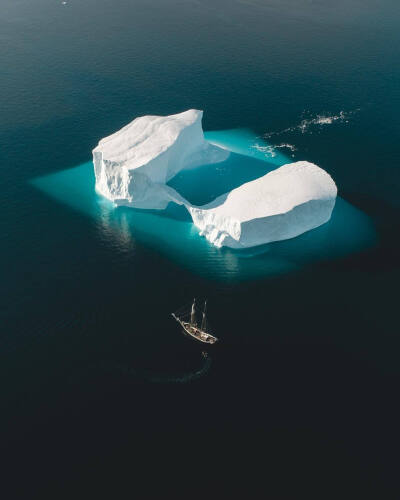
[188,161,337,248]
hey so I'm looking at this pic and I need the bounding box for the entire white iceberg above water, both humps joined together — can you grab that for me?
[93,110,337,248]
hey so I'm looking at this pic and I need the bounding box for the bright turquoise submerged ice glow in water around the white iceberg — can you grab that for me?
[32,130,374,280]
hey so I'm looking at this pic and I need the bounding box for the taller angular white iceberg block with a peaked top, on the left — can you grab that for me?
[93,109,229,210]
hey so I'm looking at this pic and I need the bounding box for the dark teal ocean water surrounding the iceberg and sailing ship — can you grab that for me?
[0,0,400,499]
